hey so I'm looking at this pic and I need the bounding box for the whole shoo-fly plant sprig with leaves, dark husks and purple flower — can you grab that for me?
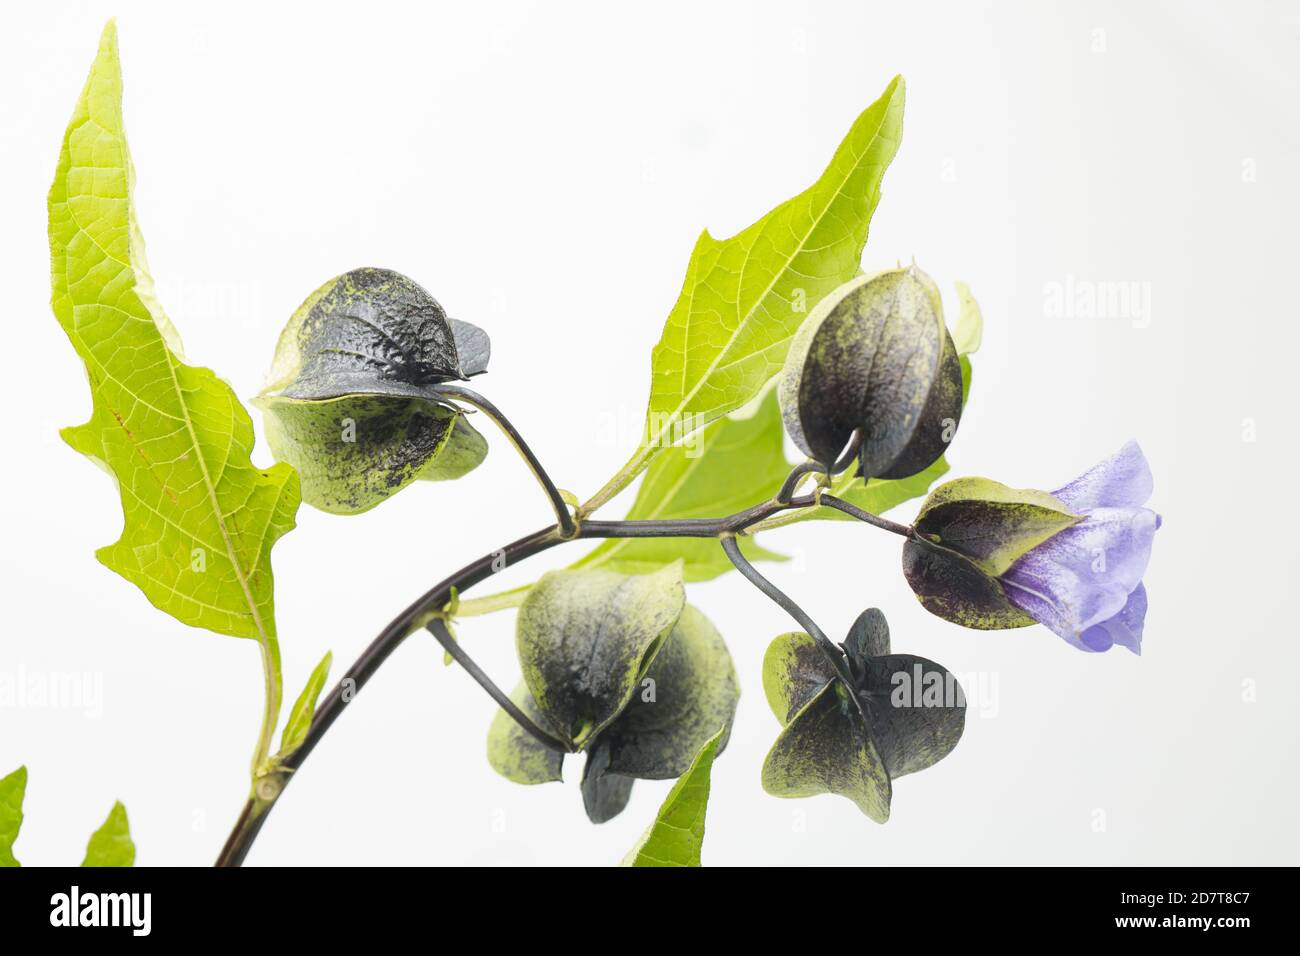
[22,23,1160,866]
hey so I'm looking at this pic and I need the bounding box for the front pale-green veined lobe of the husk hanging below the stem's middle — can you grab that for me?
[515,563,686,749]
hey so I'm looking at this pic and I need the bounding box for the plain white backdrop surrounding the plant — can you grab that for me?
[0,0,1300,865]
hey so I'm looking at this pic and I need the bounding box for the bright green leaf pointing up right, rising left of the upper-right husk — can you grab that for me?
[585,77,905,511]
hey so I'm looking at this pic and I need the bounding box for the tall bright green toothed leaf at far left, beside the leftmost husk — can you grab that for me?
[49,22,299,655]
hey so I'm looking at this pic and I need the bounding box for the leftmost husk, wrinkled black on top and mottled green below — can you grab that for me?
[255,268,490,515]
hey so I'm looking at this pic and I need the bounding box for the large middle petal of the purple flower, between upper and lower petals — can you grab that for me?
[1001,507,1160,650]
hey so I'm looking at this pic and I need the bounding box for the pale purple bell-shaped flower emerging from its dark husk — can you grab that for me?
[1001,441,1161,654]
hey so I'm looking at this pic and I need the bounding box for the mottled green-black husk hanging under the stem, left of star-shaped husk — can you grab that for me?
[488,582,740,823]
